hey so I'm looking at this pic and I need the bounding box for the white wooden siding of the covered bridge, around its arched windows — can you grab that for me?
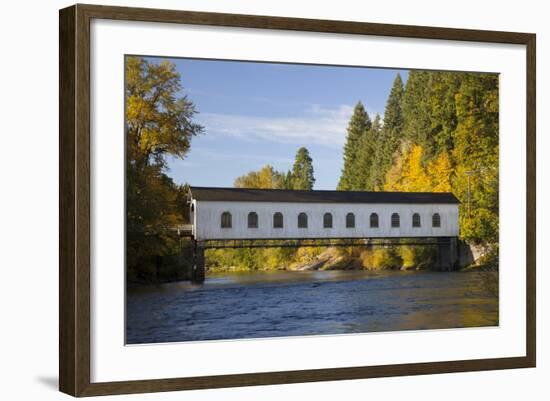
[191,199,459,241]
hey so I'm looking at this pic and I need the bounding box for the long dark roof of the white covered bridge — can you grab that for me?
[190,187,460,204]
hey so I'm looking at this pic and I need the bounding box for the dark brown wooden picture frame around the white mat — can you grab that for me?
[59,4,536,396]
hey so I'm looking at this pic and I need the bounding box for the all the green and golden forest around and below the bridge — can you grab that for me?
[125,57,499,282]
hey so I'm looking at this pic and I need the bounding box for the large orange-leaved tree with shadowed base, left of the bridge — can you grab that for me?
[125,57,203,281]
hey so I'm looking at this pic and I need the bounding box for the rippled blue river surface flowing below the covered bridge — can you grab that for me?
[126,271,498,344]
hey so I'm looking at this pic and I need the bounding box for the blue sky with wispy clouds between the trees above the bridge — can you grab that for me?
[150,59,408,189]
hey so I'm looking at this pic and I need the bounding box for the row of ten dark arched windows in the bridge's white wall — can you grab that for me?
[221,212,441,228]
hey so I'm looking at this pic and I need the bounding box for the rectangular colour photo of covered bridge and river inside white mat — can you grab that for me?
[124,55,499,344]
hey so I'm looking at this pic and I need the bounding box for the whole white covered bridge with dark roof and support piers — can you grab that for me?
[188,187,460,281]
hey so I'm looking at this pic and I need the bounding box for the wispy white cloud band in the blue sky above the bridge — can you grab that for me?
[198,105,360,148]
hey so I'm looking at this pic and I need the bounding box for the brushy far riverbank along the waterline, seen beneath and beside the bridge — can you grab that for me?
[127,243,498,284]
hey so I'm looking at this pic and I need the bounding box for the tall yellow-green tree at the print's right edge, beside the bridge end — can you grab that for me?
[452,74,499,244]
